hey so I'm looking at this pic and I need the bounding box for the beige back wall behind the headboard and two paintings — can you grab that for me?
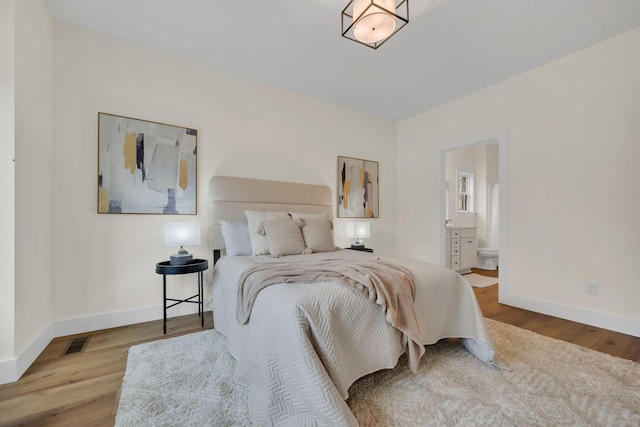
[53,23,396,328]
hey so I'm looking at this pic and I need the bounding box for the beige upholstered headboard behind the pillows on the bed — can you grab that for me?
[208,176,333,256]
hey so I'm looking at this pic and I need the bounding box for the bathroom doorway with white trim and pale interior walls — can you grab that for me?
[439,129,508,294]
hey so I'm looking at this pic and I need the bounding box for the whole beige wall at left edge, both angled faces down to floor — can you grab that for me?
[0,0,53,382]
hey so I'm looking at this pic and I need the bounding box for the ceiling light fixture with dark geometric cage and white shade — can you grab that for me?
[342,0,409,49]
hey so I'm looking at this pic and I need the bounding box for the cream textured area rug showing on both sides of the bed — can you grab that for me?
[116,319,640,427]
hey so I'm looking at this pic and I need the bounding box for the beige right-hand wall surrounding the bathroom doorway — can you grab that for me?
[398,29,640,336]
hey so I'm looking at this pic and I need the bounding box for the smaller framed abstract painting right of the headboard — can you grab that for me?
[337,156,380,218]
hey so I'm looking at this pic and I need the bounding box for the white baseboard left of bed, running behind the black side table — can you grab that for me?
[0,304,198,384]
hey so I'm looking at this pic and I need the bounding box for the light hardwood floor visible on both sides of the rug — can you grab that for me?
[0,270,640,427]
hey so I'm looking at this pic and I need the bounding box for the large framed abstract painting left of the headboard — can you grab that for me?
[98,113,198,215]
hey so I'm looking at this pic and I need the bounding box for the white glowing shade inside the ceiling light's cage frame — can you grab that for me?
[353,0,396,43]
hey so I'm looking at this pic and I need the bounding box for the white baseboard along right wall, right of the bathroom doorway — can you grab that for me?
[498,294,640,338]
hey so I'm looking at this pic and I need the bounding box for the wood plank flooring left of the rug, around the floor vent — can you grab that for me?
[0,311,213,427]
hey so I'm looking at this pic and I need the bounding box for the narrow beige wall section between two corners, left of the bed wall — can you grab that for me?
[15,0,53,362]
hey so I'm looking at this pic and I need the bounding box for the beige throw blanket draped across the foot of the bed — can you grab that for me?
[236,260,425,372]
